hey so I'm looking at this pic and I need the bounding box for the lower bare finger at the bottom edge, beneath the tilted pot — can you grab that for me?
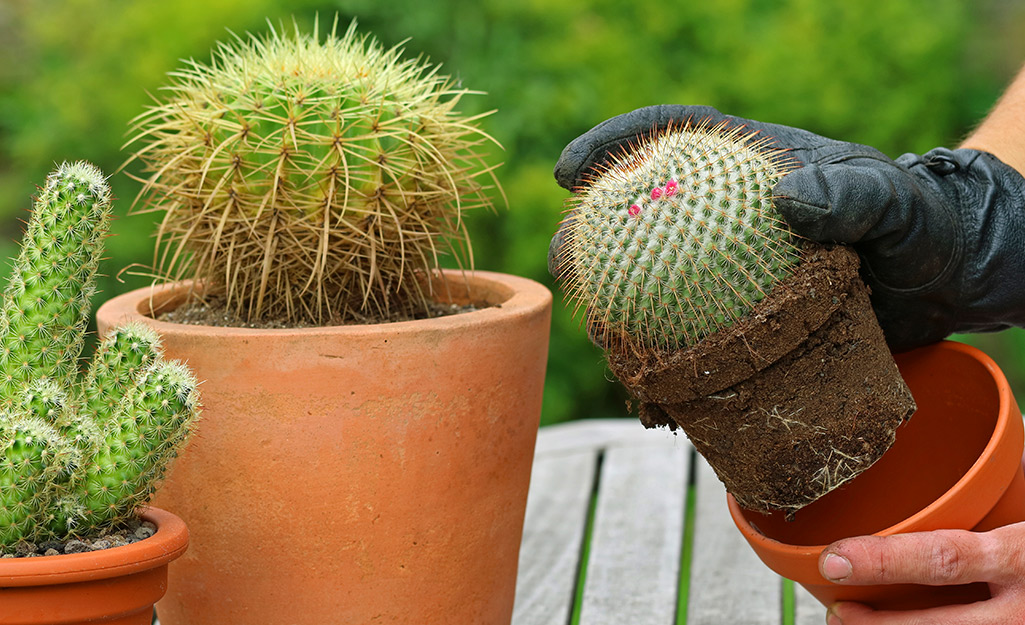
[826,594,1022,625]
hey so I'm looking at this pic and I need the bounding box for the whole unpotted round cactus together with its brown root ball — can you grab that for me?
[558,121,914,512]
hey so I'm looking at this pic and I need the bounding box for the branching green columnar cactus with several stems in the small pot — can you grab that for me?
[0,163,199,552]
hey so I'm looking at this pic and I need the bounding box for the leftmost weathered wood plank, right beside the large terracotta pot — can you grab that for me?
[513,450,599,625]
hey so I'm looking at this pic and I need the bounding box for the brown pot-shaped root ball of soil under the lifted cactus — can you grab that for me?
[609,241,914,511]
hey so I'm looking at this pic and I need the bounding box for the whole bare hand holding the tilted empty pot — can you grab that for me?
[819,523,1025,625]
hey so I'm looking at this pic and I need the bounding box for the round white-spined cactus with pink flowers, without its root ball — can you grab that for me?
[560,123,801,350]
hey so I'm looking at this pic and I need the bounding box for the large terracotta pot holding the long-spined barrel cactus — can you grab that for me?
[97,272,551,625]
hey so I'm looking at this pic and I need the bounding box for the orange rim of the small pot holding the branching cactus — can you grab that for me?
[0,506,189,588]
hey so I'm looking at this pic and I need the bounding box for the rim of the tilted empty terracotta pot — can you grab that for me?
[727,340,1023,561]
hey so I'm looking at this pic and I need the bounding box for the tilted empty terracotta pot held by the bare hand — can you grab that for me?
[729,342,1025,610]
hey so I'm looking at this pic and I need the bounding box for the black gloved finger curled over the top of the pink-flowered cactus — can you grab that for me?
[555,105,727,191]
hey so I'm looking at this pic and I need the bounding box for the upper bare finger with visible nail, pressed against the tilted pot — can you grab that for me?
[819,530,1008,585]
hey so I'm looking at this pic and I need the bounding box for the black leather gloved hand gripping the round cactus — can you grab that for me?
[548,105,1025,351]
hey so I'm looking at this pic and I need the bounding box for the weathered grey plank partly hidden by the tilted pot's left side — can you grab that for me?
[687,458,783,625]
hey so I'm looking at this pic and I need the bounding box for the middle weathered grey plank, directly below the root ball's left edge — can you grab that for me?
[578,440,690,625]
